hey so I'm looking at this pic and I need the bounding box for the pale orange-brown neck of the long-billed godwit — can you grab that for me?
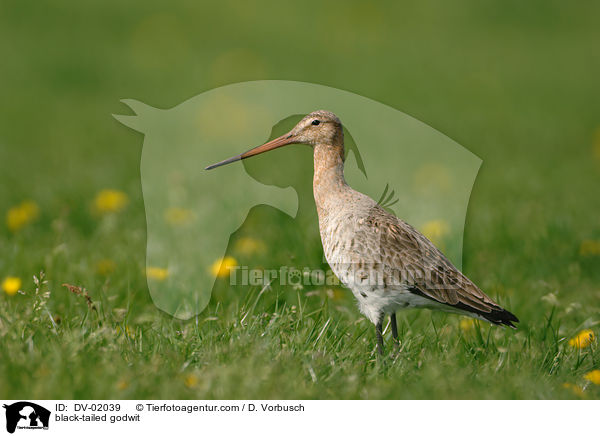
[313,144,348,217]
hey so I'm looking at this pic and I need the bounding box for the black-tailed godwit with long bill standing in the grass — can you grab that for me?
[206,110,519,354]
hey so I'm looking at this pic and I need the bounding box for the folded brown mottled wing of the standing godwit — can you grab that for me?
[365,206,518,326]
